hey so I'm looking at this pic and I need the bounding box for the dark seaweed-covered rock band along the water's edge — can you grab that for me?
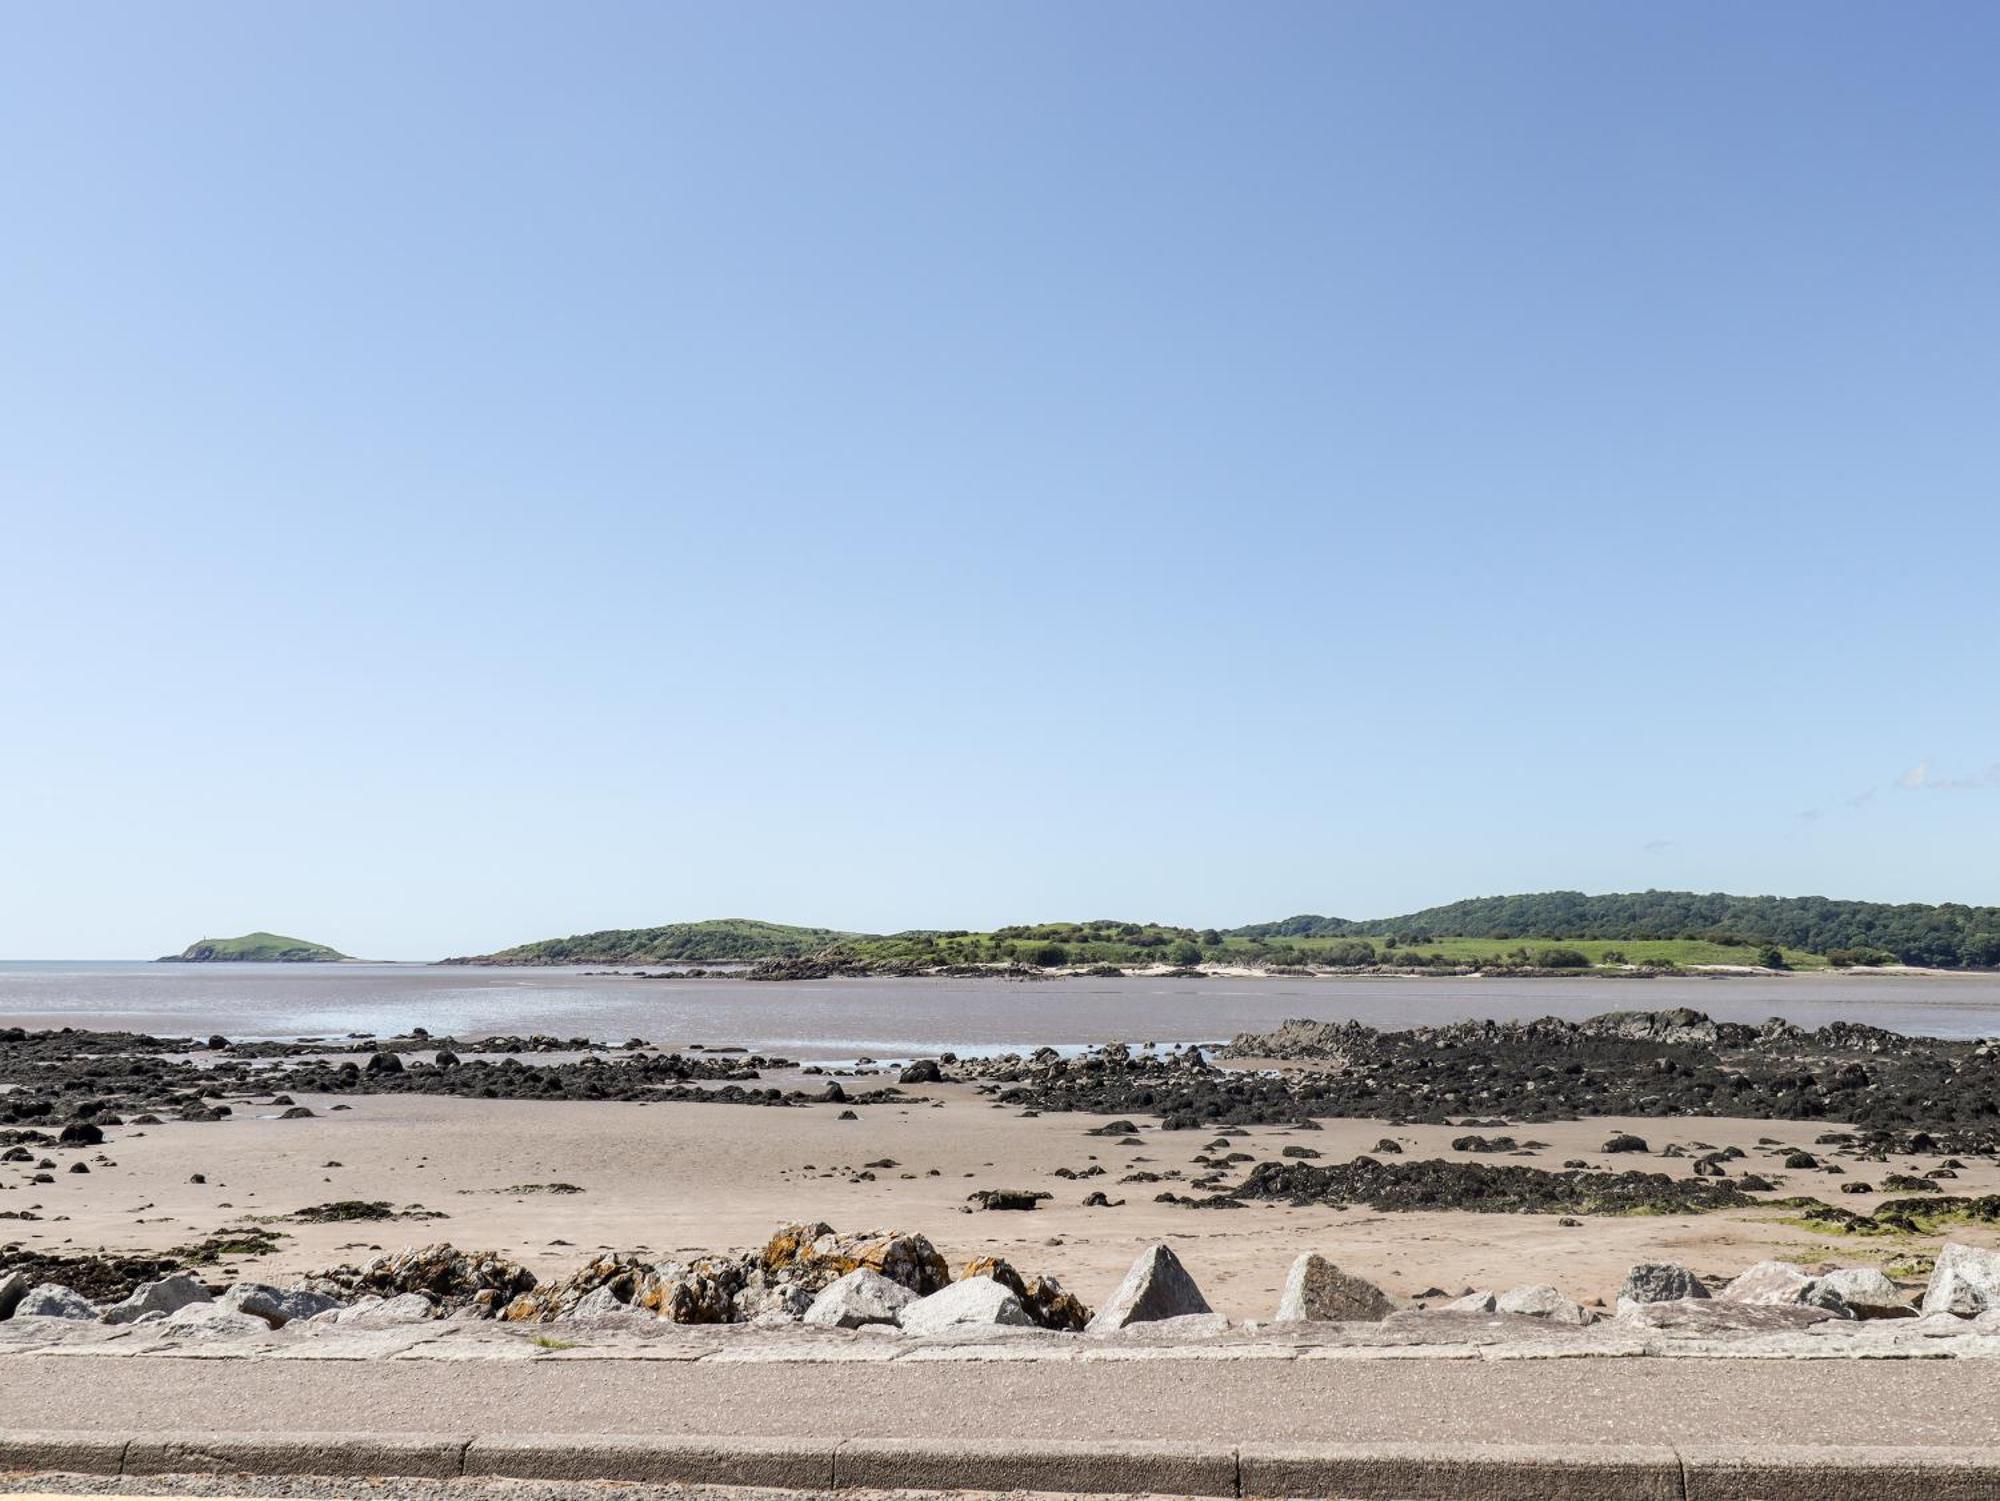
[15,1009,2000,1151]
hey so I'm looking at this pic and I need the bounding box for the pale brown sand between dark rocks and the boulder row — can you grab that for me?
[0,1085,2000,1317]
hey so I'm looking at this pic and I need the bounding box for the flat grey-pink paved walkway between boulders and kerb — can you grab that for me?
[0,1355,2000,1447]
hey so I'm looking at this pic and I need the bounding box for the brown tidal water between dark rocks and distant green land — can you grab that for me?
[11,961,2000,1061]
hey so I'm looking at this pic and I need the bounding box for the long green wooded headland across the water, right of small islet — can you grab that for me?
[444,891,2000,979]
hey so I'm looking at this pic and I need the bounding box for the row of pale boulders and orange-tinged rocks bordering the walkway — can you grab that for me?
[11,1223,2000,1337]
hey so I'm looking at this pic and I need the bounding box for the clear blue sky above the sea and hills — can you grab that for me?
[0,0,2000,957]
